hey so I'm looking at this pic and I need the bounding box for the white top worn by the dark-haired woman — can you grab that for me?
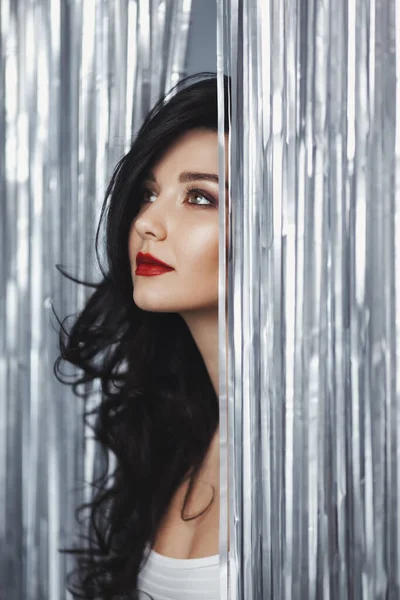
[137,549,220,600]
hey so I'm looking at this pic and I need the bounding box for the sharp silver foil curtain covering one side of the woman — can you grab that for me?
[218,0,400,600]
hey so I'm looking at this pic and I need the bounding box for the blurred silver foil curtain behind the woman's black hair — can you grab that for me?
[0,0,191,600]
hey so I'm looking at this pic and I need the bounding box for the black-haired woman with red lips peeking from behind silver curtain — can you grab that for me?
[55,74,229,600]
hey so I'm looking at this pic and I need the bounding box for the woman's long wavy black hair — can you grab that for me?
[54,73,229,600]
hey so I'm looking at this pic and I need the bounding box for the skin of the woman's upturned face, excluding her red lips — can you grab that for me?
[129,129,227,314]
